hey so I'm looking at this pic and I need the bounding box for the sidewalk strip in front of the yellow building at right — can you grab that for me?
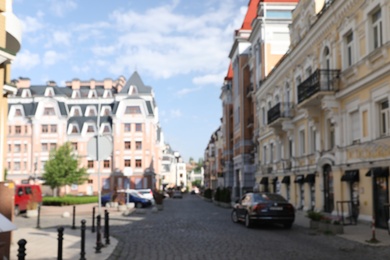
[294,211,390,246]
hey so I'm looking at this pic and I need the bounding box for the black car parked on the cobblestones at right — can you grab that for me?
[231,192,295,228]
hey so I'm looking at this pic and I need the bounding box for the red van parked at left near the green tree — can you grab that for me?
[14,184,42,215]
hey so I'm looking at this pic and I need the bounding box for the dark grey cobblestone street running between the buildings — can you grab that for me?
[109,194,390,260]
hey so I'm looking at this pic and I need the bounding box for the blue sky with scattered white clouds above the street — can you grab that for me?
[11,0,249,161]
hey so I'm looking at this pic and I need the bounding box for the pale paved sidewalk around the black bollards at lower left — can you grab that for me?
[10,204,129,260]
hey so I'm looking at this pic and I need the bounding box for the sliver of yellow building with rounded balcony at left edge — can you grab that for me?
[0,0,22,181]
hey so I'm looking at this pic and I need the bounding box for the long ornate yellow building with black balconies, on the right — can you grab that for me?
[256,0,390,227]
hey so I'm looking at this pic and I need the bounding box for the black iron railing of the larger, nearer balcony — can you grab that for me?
[298,69,340,104]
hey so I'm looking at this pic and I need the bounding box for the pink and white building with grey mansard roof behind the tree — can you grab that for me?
[6,72,164,194]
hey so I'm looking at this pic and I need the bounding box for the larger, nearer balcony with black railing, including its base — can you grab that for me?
[298,69,340,107]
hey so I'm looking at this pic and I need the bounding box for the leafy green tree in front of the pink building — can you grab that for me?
[43,142,88,196]
